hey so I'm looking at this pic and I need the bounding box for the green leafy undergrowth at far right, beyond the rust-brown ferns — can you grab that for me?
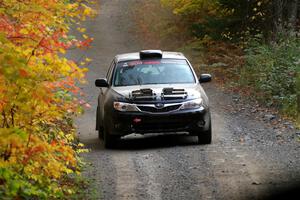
[243,36,300,119]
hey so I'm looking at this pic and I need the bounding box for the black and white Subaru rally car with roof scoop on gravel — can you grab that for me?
[95,50,212,147]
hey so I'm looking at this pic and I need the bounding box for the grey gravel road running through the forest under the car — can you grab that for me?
[70,0,300,200]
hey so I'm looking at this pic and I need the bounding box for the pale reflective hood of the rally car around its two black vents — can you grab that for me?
[112,84,206,101]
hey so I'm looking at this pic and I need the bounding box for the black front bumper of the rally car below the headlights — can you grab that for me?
[109,109,210,136]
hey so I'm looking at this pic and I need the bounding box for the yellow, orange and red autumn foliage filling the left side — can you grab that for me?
[0,0,94,199]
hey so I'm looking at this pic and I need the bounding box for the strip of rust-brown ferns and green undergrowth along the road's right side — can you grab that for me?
[198,36,300,124]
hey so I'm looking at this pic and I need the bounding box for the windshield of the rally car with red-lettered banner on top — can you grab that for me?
[114,59,195,86]
